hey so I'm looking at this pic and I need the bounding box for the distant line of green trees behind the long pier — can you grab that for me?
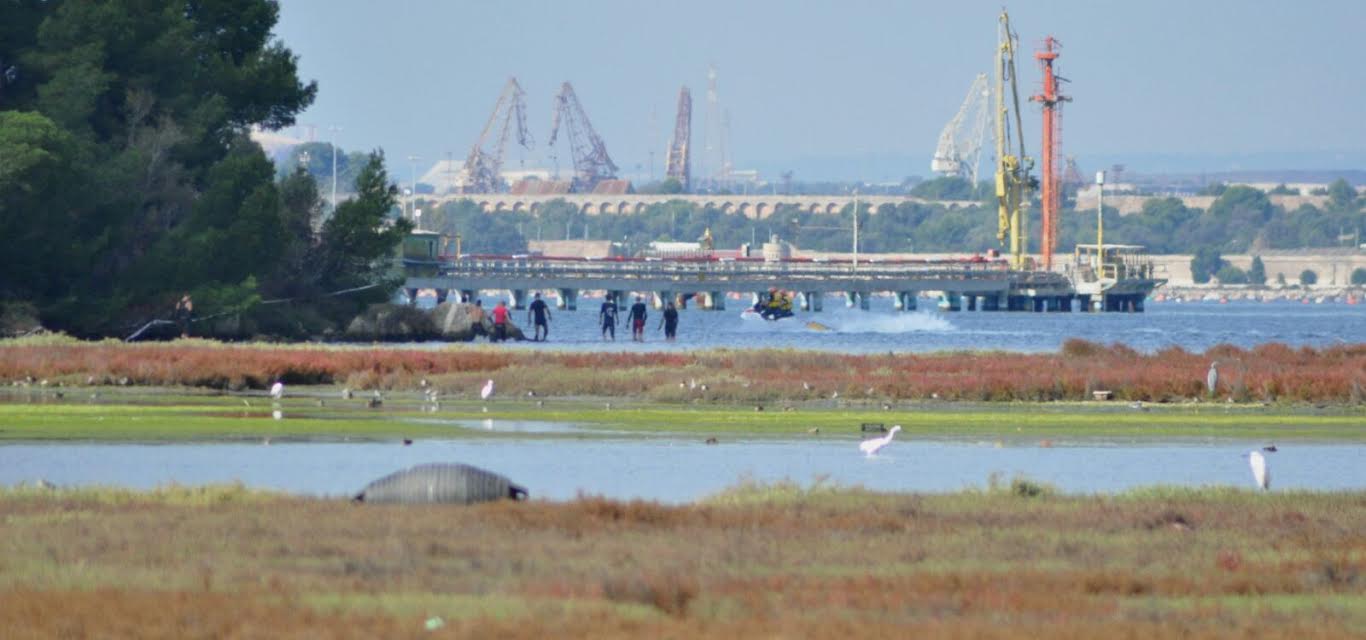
[422,179,1366,254]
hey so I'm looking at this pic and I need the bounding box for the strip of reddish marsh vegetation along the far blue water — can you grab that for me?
[0,338,1366,403]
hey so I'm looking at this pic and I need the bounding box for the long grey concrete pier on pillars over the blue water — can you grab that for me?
[404,255,1143,311]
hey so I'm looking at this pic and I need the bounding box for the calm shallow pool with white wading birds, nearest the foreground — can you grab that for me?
[0,427,1366,502]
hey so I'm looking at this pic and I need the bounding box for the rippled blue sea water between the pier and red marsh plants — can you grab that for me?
[412,296,1366,353]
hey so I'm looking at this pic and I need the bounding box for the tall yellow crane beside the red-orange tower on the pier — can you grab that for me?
[996,10,1034,269]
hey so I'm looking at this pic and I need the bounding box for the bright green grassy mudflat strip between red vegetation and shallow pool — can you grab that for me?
[0,388,1366,442]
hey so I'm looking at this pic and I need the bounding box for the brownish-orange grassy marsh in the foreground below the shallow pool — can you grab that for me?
[0,482,1366,639]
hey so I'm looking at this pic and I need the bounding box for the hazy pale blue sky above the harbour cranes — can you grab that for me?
[276,0,1366,181]
